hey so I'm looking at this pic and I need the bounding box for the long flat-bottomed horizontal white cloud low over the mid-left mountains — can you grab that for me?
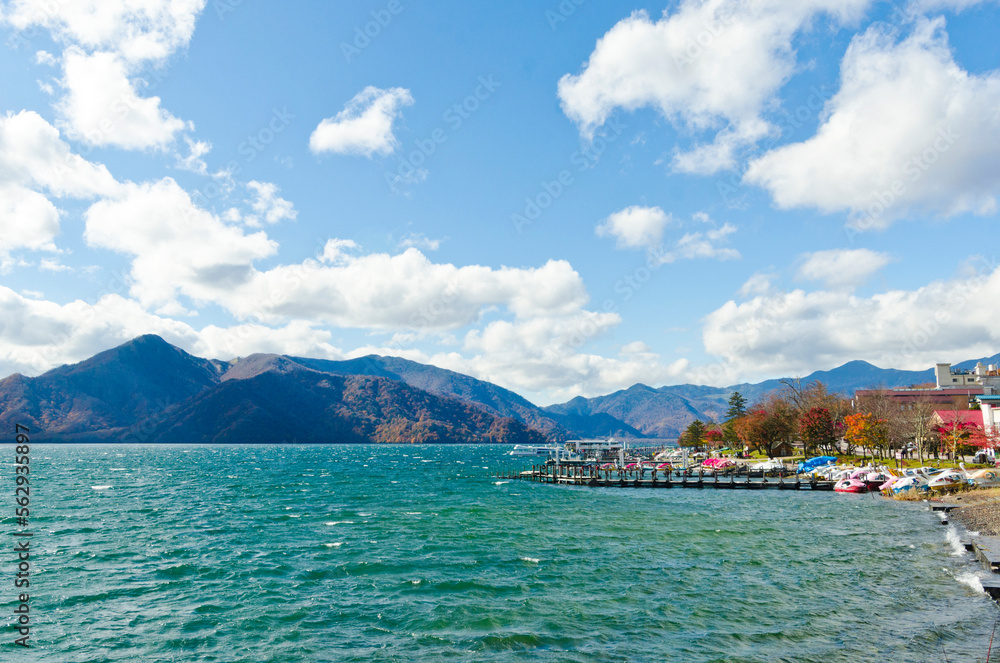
[236,245,587,332]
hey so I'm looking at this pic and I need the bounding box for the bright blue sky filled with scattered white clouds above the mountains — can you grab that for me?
[0,0,1000,404]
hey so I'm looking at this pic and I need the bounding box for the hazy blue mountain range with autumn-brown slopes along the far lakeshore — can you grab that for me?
[0,335,1000,444]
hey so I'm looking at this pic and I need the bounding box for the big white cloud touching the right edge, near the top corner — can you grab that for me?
[744,19,1000,229]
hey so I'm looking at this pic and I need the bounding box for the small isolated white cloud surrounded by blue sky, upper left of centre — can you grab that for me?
[309,85,413,157]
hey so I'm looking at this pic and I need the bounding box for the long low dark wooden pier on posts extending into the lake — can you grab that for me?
[496,465,836,490]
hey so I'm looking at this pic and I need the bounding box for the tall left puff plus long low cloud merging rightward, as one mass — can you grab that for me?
[78,178,600,332]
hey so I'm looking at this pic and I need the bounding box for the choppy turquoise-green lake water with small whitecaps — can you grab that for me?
[0,445,1000,663]
